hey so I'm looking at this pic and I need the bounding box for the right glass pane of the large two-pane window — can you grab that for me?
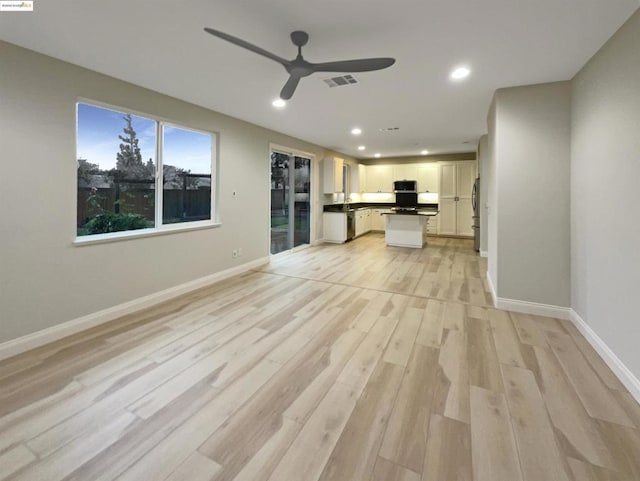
[162,126,212,224]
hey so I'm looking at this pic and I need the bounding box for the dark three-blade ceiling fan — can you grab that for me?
[204,27,396,100]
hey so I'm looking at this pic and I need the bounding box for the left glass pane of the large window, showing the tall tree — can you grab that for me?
[77,103,156,236]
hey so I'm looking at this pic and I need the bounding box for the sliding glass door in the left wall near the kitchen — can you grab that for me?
[271,150,311,254]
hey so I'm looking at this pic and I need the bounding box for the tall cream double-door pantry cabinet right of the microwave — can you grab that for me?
[438,160,477,237]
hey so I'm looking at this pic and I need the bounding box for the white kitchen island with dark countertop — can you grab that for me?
[384,209,439,249]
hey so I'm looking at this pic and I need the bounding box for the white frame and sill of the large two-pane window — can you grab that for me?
[73,98,221,246]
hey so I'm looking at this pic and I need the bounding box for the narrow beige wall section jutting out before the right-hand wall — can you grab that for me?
[489,82,571,307]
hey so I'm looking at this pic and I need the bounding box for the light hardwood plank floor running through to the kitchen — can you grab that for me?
[0,234,640,481]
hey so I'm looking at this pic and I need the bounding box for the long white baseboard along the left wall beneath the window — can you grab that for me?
[0,257,269,360]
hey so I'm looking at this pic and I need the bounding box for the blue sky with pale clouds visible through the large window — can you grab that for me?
[77,103,211,174]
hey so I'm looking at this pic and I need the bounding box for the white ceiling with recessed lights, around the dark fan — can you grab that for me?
[0,0,638,158]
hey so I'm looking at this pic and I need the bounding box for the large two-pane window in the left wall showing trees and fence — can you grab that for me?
[77,103,215,237]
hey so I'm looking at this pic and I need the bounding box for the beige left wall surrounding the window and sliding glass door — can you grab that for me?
[0,42,344,343]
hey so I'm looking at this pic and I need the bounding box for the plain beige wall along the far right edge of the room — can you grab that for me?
[571,6,640,377]
